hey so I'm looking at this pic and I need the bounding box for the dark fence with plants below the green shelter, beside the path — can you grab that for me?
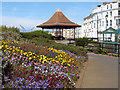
[87,42,120,57]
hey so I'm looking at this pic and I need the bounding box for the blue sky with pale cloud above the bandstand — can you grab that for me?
[1,2,115,31]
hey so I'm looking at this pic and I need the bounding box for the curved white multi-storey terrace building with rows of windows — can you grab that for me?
[82,1,120,41]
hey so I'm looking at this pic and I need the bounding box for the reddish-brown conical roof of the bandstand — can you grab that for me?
[37,8,81,29]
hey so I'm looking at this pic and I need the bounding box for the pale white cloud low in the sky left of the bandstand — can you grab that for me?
[2,16,44,31]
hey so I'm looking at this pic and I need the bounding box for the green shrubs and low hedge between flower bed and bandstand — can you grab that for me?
[21,30,87,56]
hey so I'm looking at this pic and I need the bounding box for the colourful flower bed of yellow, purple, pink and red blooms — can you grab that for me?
[1,40,87,88]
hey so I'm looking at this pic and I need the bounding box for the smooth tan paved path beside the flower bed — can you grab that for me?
[81,54,118,88]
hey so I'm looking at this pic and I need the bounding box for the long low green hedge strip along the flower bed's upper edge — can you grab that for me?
[31,37,87,56]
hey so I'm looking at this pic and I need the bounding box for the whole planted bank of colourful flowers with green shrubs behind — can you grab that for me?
[0,25,88,88]
